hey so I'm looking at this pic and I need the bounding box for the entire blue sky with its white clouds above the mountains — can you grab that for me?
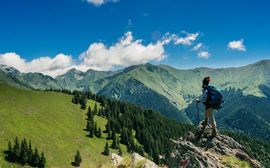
[0,0,270,76]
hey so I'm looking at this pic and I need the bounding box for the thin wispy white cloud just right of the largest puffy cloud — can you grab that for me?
[162,31,200,46]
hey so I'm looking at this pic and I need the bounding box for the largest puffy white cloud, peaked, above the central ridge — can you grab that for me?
[79,32,166,70]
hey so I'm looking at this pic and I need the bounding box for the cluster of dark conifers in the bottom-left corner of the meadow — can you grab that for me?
[5,137,46,168]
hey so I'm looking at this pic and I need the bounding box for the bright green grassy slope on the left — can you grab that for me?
[0,84,129,167]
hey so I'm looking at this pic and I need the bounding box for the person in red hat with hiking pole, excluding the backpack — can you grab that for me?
[196,76,219,137]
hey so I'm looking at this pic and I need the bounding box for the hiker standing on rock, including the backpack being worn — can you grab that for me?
[196,76,222,137]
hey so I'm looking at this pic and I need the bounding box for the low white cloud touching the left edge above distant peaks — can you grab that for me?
[0,53,73,77]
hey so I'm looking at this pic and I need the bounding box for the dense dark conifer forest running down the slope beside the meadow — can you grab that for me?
[72,91,195,164]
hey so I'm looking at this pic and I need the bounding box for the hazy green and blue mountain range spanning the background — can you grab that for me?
[0,60,270,140]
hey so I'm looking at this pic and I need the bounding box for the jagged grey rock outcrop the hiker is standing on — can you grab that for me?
[168,126,263,168]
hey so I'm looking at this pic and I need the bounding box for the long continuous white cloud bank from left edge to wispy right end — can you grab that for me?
[0,32,198,77]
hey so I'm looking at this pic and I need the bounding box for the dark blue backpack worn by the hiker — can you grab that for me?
[207,86,223,109]
